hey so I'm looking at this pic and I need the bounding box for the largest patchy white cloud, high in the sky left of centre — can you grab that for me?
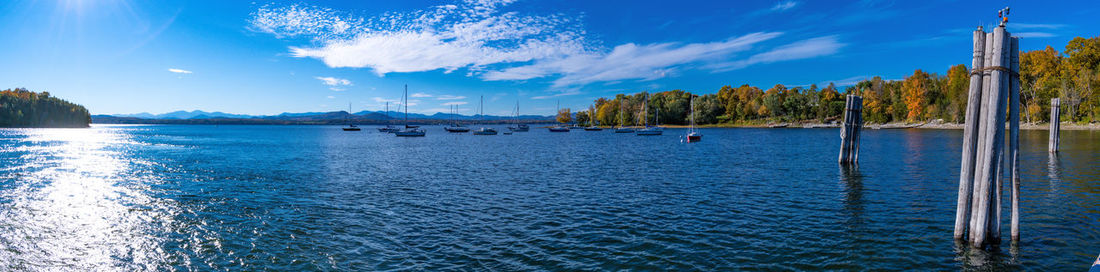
[251,1,585,76]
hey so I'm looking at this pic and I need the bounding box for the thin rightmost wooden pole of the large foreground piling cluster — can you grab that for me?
[1009,37,1020,241]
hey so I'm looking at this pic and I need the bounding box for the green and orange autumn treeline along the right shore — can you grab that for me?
[576,37,1100,126]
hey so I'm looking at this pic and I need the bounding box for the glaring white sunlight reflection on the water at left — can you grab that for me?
[0,128,166,271]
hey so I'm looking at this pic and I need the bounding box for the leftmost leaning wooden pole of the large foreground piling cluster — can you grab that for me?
[955,26,986,240]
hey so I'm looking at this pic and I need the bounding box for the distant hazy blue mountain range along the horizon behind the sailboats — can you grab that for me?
[91,110,554,124]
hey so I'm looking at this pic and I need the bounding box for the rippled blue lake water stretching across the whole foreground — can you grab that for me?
[0,126,1100,271]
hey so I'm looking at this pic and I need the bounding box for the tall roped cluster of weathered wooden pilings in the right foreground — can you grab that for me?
[955,24,1020,247]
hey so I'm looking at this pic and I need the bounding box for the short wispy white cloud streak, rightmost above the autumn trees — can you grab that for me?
[710,35,844,72]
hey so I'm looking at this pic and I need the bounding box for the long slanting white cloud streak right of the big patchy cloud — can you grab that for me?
[482,32,782,87]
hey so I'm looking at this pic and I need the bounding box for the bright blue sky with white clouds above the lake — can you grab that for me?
[0,0,1100,115]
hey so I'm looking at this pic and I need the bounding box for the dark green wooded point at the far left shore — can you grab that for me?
[0,88,91,128]
